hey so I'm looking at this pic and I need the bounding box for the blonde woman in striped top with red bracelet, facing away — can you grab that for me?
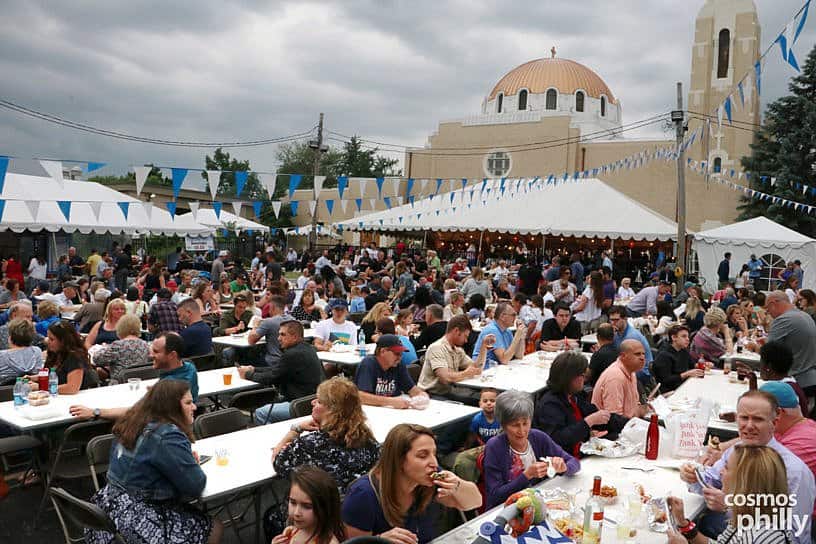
[668,444,792,544]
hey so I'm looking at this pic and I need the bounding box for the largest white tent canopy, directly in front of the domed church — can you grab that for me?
[339,179,677,241]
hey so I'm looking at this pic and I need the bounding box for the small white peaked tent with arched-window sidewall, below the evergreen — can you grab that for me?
[692,217,816,288]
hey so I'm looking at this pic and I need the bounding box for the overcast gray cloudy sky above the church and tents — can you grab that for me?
[0,0,816,185]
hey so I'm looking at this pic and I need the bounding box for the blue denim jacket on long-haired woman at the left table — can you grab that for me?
[108,423,207,502]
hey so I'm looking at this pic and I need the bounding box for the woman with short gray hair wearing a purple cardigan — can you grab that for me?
[484,390,581,508]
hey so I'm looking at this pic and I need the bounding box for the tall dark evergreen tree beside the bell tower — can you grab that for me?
[739,44,816,237]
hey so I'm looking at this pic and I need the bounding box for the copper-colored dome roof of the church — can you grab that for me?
[488,58,616,104]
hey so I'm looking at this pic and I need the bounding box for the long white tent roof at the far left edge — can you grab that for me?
[0,173,212,236]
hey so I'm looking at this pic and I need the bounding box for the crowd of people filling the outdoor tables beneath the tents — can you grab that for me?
[0,244,816,544]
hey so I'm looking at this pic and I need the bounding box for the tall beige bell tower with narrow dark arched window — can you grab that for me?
[687,0,760,172]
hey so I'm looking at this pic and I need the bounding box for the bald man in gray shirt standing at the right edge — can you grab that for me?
[765,291,816,399]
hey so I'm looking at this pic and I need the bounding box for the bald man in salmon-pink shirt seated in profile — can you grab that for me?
[592,340,648,418]
